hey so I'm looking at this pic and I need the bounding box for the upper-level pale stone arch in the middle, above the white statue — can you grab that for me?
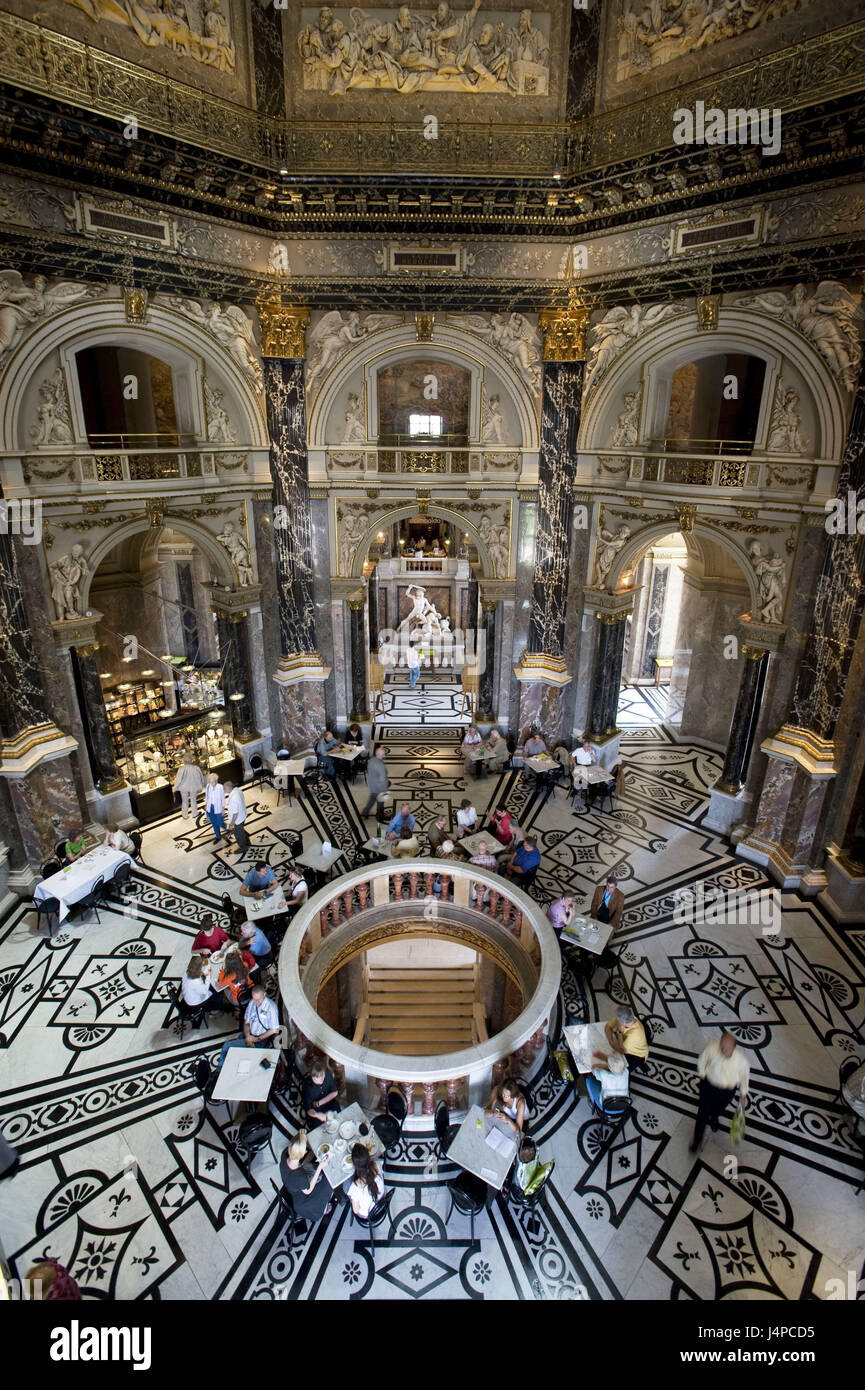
[307,322,541,453]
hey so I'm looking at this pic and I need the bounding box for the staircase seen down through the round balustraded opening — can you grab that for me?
[355,965,487,1056]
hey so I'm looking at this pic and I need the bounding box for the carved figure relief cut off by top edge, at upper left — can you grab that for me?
[67,0,236,72]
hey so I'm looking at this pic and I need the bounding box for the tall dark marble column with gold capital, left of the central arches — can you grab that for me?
[259,300,330,748]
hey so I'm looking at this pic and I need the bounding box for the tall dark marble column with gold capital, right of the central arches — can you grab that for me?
[515,300,590,742]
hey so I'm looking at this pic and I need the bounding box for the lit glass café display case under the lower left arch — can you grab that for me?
[124,709,243,821]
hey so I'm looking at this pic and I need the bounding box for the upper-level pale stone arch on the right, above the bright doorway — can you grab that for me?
[579,304,847,459]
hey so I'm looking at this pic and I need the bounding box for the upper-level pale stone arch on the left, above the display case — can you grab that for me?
[0,297,268,453]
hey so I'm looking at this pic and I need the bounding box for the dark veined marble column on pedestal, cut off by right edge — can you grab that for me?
[738,350,865,894]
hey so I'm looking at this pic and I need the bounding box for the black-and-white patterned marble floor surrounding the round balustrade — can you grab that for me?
[0,720,865,1300]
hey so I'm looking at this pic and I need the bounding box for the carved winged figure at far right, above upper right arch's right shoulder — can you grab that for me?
[736,279,862,391]
